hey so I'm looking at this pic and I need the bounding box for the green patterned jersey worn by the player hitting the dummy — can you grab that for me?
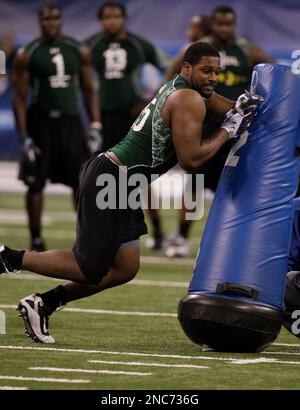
[110,74,190,177]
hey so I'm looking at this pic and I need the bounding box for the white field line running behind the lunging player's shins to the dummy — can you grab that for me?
[3,273,189,289]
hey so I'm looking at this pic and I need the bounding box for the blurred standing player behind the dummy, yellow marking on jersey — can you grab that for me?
[161,6,274,257]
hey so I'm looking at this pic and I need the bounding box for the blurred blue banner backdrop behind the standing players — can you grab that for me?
[0,0,300,158]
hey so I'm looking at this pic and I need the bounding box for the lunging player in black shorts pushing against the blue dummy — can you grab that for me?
[0,43,258,343]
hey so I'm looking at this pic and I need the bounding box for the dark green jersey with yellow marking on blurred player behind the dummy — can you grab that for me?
[201,36,252,100]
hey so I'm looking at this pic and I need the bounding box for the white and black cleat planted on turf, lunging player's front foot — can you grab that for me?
[17,294,55,343]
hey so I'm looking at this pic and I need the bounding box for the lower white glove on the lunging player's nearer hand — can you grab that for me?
[220,109,256,139]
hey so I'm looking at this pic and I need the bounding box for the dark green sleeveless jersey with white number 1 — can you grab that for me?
[26,36,81,114]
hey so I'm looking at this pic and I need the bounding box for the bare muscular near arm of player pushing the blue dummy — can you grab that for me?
[165,90,229,170]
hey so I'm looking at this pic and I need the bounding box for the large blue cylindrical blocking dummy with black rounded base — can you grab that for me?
[178,64,300,352]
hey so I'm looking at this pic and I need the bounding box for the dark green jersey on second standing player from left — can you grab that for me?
[86,33,169,111]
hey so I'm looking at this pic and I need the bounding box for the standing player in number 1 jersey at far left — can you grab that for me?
[12,3,101,251]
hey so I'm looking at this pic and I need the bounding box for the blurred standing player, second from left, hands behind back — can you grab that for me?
[86,1,169,150]
